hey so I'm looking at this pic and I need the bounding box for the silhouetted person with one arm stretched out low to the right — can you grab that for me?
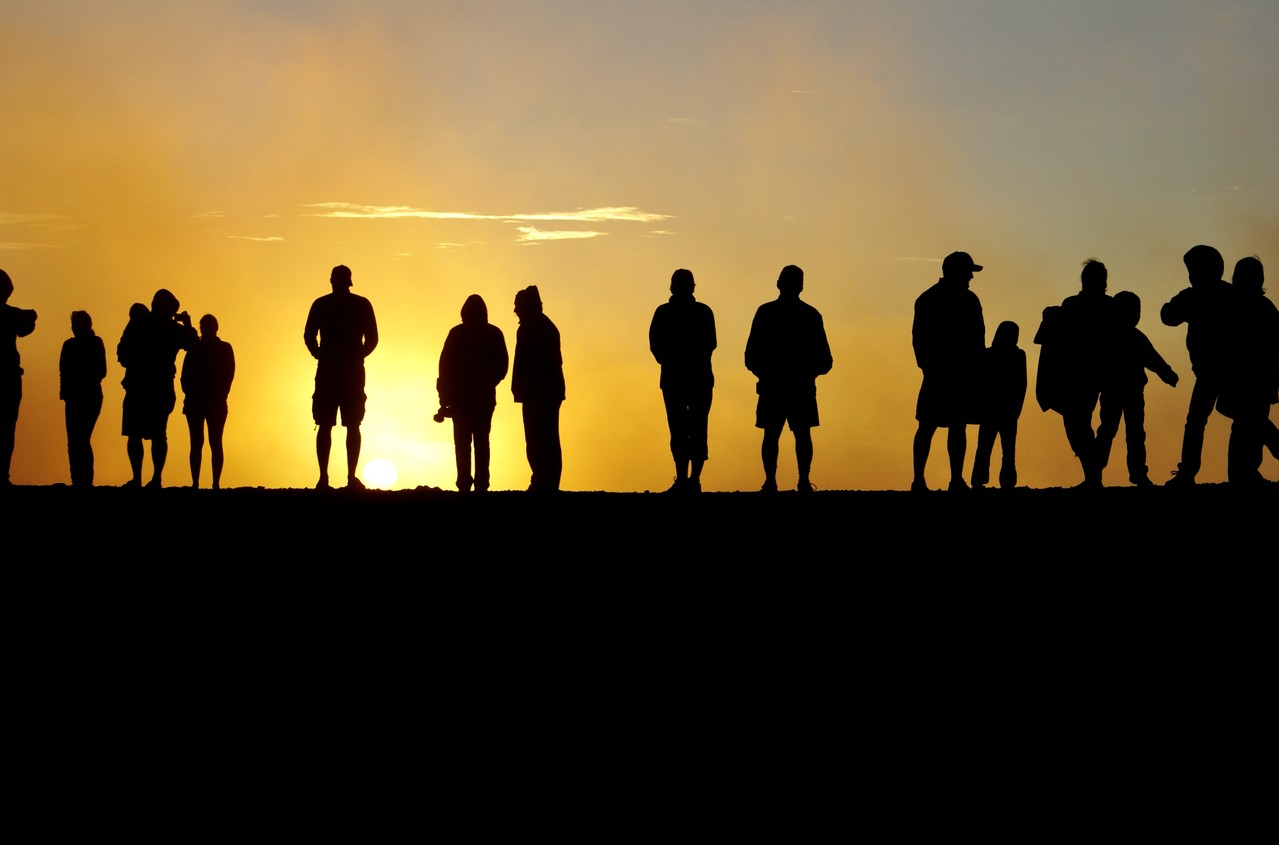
[1097,290,1177,487]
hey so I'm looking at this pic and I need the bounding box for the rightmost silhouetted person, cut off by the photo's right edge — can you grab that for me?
[1216,256,1279,485]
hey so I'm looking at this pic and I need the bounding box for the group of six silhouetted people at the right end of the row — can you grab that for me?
[911,244,1279,491]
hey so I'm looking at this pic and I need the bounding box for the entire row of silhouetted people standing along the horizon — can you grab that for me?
[0,244,1279,493]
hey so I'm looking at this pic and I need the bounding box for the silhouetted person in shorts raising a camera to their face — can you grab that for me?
[115,289,197,488]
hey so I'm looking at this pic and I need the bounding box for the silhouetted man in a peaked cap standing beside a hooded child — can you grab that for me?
[911,252,986,492]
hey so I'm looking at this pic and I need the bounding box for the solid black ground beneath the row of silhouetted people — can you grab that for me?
[9,486,1279,813]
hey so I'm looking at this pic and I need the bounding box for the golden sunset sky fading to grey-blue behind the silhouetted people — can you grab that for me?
[0,0,1279,491]
